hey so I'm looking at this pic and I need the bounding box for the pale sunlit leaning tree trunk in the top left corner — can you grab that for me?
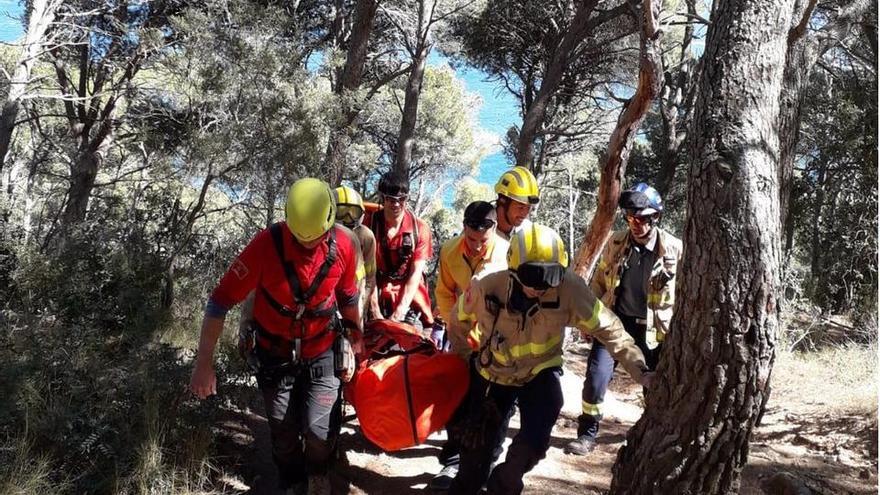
[0,0,60,172]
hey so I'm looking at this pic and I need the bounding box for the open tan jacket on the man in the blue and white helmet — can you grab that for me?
[590,228,682,349]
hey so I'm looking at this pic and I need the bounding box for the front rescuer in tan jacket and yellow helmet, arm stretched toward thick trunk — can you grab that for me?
[449,224,649,495]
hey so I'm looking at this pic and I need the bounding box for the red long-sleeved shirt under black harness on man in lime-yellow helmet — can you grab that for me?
[211,222,358,359]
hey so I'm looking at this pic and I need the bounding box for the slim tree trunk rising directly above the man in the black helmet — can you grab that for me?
[393,0,436,176]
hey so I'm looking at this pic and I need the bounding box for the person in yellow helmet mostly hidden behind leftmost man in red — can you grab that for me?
[336,186,379,314]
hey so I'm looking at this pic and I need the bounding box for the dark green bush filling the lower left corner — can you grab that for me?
[0,230,244,494]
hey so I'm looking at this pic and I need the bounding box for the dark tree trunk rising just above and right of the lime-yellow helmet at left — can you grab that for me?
[324,0,379,187]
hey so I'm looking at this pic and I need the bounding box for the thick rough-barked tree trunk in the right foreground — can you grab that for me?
[611,0,794,494]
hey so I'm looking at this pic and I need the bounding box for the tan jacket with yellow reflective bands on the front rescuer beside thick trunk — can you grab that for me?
[448,270,647,386]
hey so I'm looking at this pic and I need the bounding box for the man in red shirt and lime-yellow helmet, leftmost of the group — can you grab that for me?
[190,178,361,494]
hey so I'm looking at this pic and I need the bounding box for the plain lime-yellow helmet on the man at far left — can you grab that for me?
[284,177,336,242]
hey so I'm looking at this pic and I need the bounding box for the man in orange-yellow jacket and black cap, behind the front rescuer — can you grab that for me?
[429,201,509,490]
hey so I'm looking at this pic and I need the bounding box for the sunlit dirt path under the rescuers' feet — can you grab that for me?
[219,348,877,495]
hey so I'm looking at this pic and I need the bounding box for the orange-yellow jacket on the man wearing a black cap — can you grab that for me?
[434,234,509,321]
